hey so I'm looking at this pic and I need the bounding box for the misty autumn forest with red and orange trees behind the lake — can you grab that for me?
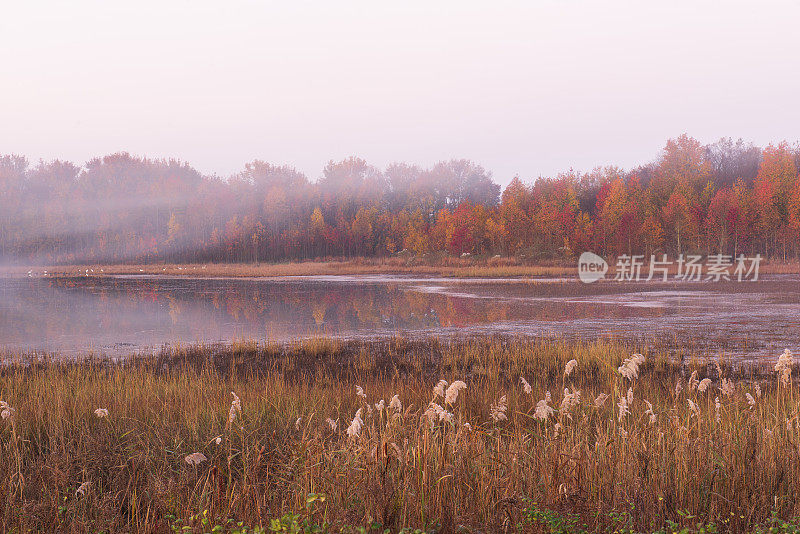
[0,135,800,265]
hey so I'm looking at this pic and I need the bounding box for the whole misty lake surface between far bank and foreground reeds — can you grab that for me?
[0,275,800,360]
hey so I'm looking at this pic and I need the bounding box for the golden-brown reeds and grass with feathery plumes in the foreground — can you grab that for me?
[0,337,800,533]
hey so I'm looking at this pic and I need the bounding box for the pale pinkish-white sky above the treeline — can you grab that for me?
[0,0,800,184]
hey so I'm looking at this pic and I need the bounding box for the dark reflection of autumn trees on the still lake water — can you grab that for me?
[0,278,663,352]
